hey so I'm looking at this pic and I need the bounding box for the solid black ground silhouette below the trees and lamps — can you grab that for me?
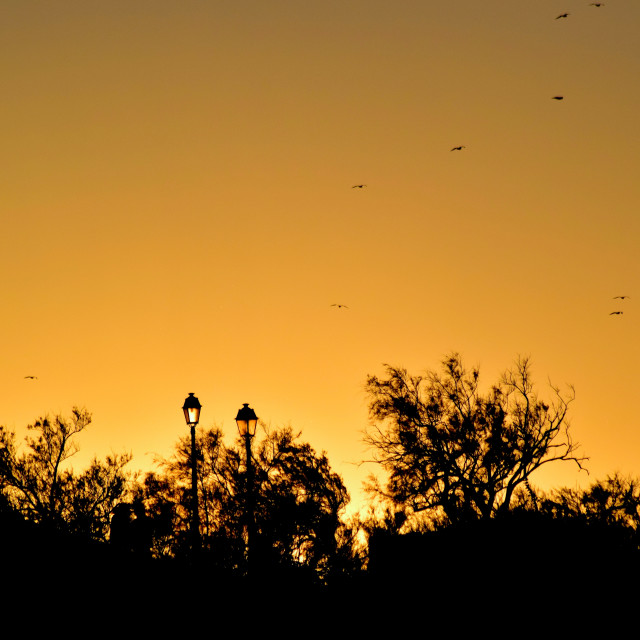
[0,496,640,632]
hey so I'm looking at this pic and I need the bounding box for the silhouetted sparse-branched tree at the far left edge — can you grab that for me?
[0,407,131,541]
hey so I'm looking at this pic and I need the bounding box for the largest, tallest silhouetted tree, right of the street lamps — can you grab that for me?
[365,354,584,523]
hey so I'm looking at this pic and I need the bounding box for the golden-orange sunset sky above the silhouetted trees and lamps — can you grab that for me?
[0,0,640,504]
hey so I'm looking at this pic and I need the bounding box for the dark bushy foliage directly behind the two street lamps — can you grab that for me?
[138,427,359,579]
